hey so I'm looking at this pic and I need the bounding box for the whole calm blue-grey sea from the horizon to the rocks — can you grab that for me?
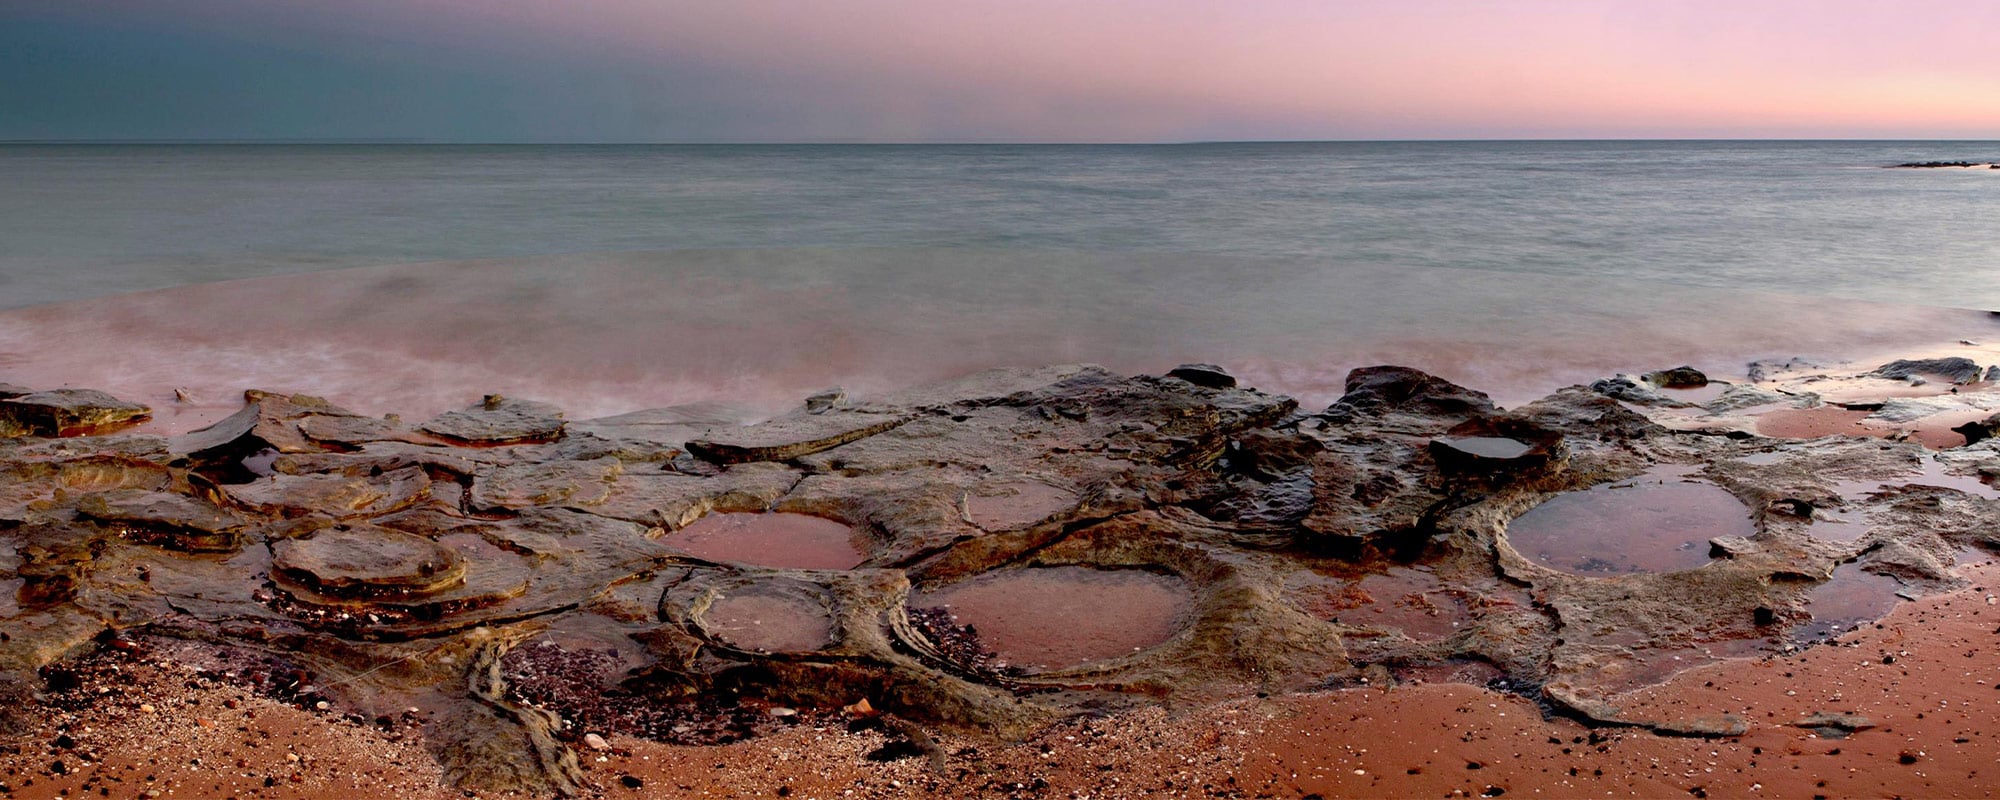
[0,142,2000,426]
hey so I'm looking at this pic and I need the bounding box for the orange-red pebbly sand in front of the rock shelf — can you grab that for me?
[0,564,2000,798]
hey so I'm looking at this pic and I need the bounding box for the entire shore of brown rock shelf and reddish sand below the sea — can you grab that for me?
[0,316,2000,798]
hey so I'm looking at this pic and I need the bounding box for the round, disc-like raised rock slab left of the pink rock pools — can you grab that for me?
[270,526,466,598]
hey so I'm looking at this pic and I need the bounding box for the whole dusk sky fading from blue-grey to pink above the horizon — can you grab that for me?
[0,0,2000,142]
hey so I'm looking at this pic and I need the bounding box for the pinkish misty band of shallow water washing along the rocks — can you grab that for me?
[0,252,1994,432]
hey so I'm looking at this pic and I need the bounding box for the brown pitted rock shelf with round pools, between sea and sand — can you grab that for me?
[0,364,2000,794]
